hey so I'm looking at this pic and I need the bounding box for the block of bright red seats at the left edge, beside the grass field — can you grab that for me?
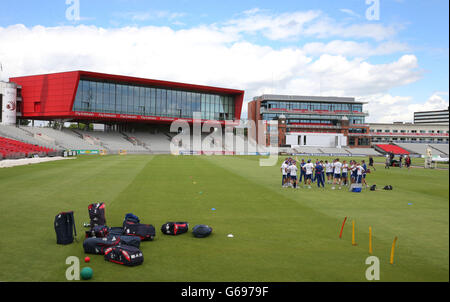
[0,137,57,159]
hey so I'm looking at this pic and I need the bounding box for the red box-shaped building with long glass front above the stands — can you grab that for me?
[10,71,244,124]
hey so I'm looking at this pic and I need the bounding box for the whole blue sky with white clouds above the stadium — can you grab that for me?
[0,0,449,121]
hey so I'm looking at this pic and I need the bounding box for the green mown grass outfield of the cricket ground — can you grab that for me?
[0,155,449,282]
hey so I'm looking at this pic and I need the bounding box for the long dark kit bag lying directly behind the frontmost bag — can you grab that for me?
[83,236,141,255]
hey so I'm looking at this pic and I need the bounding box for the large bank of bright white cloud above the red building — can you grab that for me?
[0,9,422,119]
